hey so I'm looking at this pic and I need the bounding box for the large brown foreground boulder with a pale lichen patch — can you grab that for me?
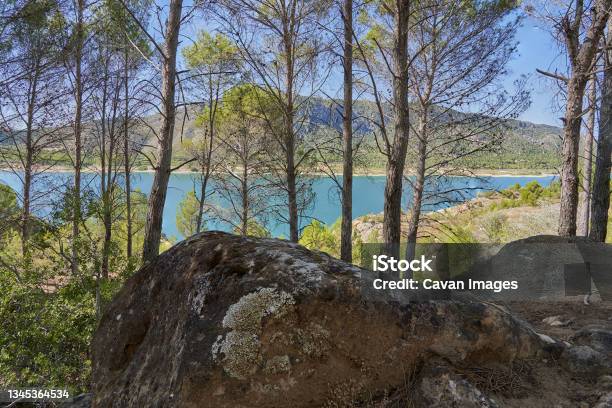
[92,232,542,407]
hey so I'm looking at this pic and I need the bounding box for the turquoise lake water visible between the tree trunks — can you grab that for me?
[0,171,554,239]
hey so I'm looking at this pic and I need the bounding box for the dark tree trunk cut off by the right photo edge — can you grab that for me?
[589,18,612,242]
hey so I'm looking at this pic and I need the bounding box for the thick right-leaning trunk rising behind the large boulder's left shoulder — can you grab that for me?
[142,0,183,262]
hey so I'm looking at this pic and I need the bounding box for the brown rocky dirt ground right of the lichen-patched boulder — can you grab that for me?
[490,298,612,408]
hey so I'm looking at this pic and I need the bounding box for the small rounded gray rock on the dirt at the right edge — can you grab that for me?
[561,346,612,379]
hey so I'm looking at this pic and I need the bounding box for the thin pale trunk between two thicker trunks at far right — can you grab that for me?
[577,75,597,237]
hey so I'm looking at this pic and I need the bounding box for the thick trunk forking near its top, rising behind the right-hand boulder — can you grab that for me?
[558,0,612,236]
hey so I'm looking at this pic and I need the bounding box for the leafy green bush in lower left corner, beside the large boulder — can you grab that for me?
[0,262,97,393]
